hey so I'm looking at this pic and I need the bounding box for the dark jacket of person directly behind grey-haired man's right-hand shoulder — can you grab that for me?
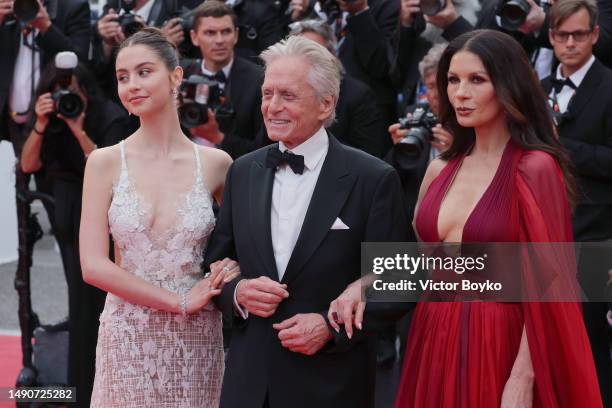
[329,75,389,157]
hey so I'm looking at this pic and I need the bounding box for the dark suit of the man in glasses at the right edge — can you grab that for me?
[542,60,612,406]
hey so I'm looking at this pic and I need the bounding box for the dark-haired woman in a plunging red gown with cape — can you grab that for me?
[395,30,602,408]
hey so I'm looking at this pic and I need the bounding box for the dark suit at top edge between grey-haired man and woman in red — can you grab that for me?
[338,0,400,126]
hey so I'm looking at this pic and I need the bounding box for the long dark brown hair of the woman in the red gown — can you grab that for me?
[436,30,575,203]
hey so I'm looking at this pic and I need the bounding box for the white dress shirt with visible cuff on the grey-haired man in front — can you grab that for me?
[234,127,329,319]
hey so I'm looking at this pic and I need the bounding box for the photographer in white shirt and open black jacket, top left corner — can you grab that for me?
[0,0,91,156]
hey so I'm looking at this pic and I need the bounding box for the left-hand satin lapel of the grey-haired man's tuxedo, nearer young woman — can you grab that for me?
[249,149,278,280]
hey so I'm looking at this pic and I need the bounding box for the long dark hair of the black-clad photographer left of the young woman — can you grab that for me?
[31,61,105,134]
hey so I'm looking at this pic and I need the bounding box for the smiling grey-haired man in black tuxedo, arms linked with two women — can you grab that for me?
[204,36,409,408]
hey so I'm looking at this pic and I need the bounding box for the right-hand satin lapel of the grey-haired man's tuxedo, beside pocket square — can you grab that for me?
[282,135,355,283]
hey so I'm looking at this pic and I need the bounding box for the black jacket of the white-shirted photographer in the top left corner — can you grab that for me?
[0,0,91,136]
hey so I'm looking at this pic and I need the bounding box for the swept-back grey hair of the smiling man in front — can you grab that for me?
[260,35,340,127]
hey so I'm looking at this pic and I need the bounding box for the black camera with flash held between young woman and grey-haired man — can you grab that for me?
[179,75,235,132]
